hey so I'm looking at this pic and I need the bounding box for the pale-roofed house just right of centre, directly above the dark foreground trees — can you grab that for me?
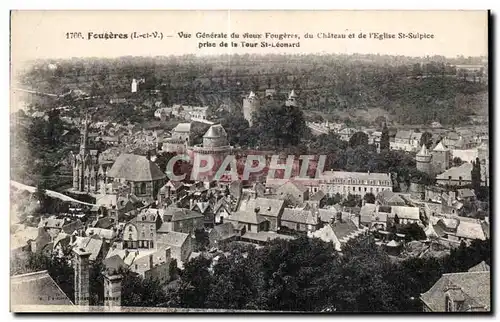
[281,207,321,232]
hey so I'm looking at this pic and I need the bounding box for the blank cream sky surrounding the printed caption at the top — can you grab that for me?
[11,10,488,65]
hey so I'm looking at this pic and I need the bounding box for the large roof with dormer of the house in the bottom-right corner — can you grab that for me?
[420,271,491,312]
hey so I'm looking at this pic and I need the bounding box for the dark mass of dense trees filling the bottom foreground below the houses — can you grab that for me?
[162,237,490,312]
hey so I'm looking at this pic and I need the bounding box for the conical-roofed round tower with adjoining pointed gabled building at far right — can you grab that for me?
[416,142,451,175]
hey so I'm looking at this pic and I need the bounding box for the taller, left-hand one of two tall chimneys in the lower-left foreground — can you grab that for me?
[73,248,90,306]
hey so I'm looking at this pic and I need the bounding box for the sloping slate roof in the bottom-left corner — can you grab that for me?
[10,271,73,306]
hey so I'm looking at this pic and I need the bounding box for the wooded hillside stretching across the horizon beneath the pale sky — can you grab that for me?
[18,55,488,125]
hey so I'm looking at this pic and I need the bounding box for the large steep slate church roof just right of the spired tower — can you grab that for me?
[108,153,166,182]
